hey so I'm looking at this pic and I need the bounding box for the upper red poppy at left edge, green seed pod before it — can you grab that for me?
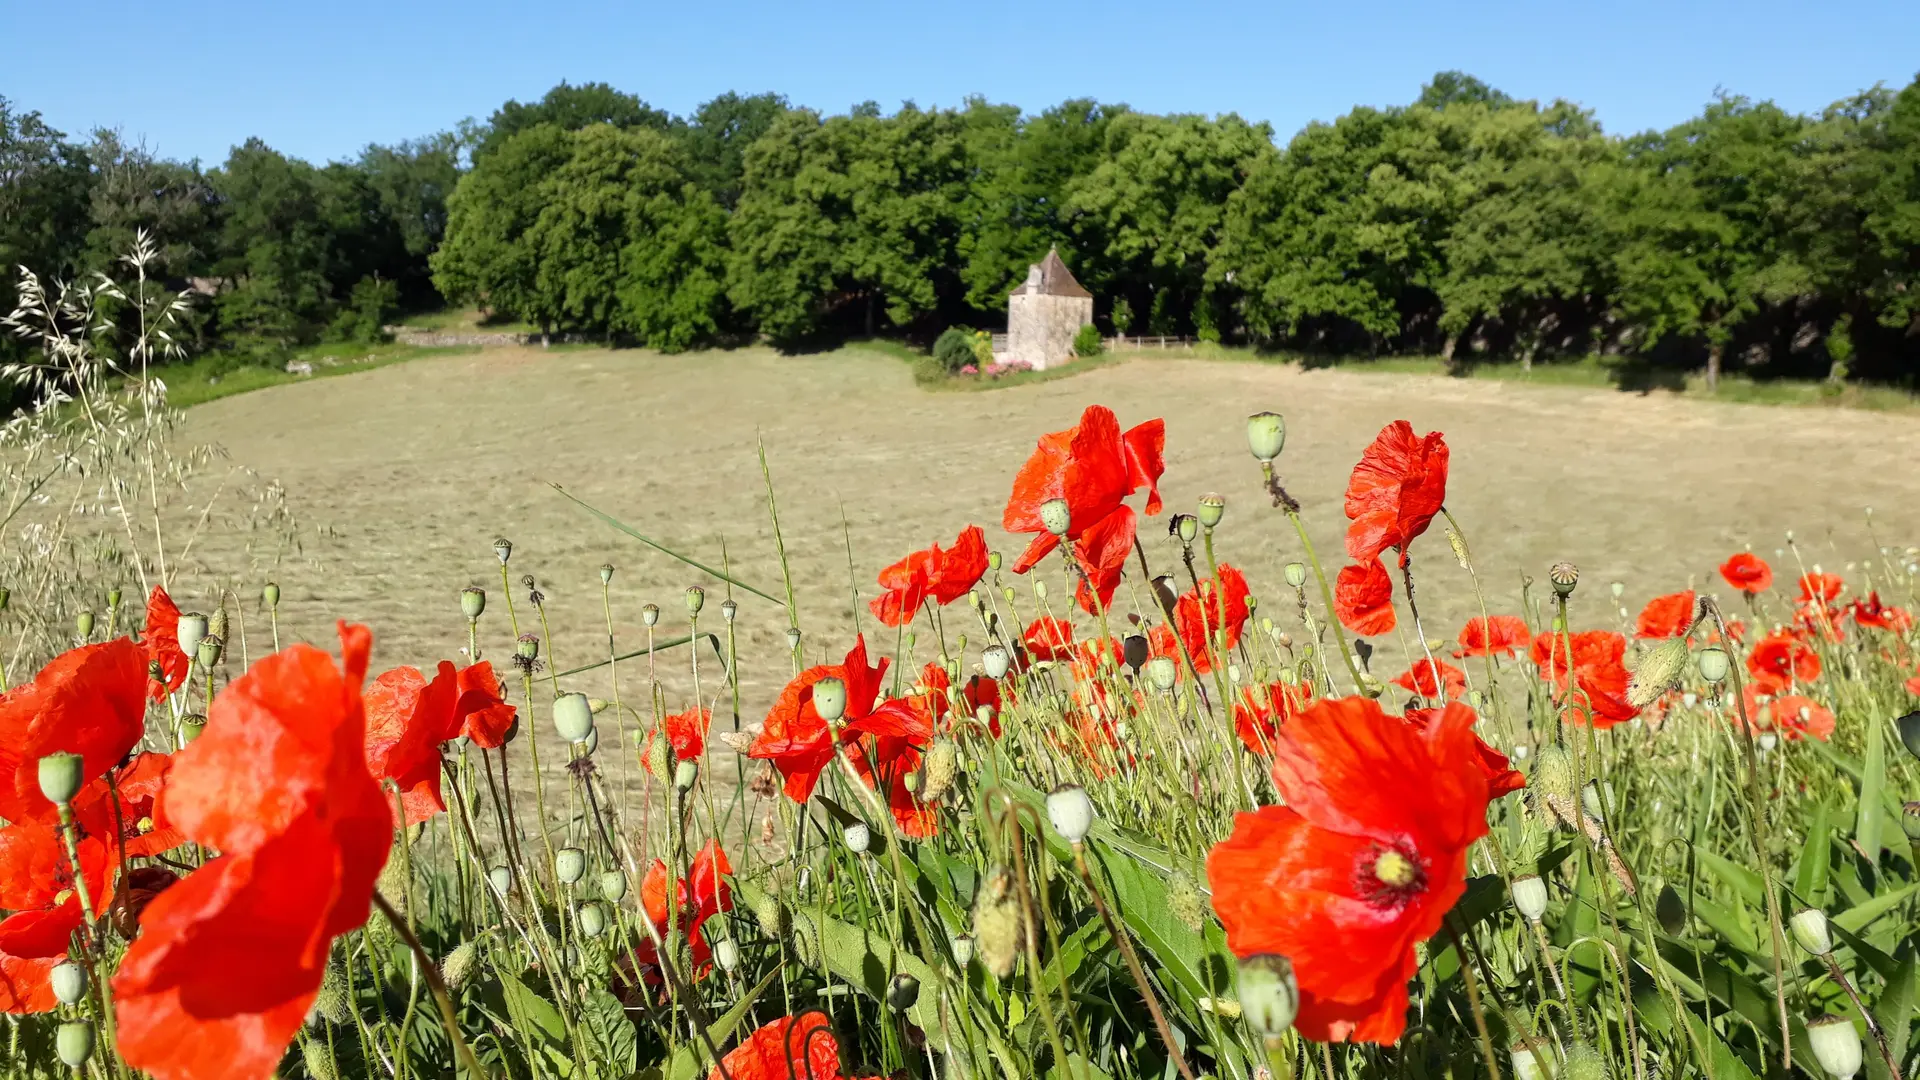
[0,638,146,822]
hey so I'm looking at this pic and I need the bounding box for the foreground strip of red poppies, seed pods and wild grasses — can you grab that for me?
[0,253,1920,1080]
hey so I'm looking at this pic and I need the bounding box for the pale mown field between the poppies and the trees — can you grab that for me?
[188,350,1920,780]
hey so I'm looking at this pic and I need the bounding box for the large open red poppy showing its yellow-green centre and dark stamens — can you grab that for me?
[1208,698,1488,1043]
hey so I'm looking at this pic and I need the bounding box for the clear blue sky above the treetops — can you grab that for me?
[0,0,1920,163]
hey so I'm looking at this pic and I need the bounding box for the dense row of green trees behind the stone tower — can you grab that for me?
[0,73,1920,386]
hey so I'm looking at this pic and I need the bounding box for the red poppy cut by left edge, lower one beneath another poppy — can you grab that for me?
[0,821,113,1013]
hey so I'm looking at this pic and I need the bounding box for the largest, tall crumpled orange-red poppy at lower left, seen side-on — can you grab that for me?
[113,623,394,1080]
